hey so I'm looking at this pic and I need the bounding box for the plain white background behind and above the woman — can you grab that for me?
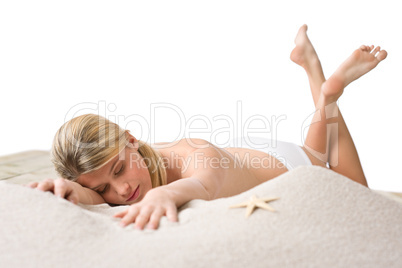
[0,0,402,192]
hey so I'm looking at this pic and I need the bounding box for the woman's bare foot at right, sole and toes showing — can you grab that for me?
[321,46,387,100]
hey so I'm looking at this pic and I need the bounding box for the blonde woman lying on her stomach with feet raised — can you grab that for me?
[29,25,387,229]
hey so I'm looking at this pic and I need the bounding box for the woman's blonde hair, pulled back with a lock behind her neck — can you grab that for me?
[51,114,167,187]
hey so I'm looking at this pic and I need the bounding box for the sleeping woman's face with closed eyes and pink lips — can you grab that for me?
[77,140,152,205]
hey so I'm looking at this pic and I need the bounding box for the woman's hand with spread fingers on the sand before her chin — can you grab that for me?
[114,187,177,230]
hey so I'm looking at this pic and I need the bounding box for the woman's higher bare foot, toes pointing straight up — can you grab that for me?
[290,24,319,69]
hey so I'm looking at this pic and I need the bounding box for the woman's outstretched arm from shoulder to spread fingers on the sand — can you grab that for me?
[115,139,232,229]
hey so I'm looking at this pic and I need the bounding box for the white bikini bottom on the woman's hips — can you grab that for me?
[229,137,312,170]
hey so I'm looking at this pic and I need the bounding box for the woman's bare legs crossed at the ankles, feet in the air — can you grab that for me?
[291,25,387,186]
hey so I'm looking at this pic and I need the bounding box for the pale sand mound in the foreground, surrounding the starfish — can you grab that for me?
[0,167,402,267]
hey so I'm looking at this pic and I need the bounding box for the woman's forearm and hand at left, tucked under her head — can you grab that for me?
[28,178,105,205]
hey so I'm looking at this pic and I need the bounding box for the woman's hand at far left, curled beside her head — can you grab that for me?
[27,178,80,204]
